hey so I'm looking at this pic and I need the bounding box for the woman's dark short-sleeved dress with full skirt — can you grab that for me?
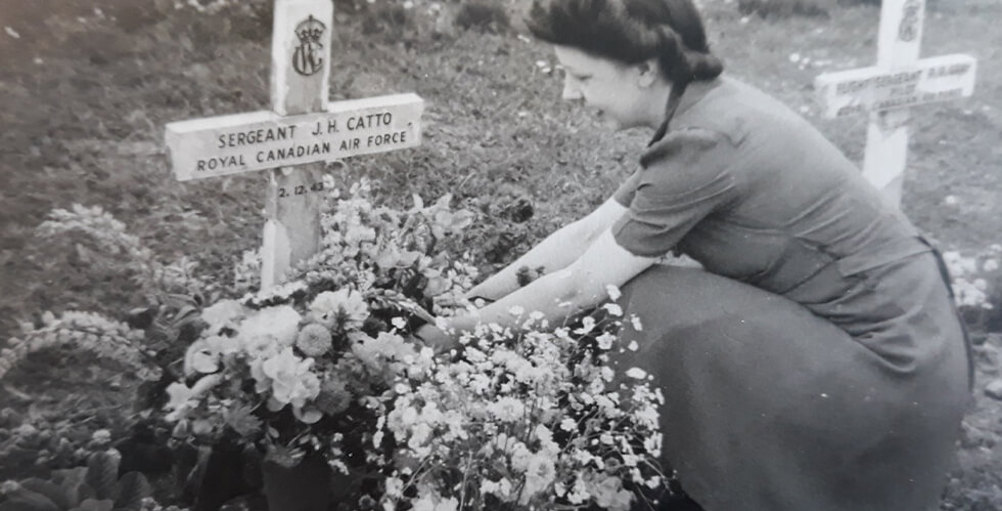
[612,75,970,511]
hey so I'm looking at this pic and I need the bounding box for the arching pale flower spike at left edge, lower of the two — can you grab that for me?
[0,311,153,380]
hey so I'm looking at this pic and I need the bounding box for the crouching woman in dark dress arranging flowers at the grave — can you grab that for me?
[418,0,970,511]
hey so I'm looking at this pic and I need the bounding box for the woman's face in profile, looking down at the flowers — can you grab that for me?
[554,45,661,129]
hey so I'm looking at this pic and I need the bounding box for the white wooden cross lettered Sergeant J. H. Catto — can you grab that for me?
[165,0,424,289]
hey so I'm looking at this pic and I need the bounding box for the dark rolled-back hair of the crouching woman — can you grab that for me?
[526,0,723,144]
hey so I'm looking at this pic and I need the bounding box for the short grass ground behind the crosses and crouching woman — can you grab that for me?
[0,0,1002,509]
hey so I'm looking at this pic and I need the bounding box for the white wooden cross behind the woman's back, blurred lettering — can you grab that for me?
[815,0,977,204]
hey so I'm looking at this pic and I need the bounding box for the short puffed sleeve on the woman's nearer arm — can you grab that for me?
[612,128,736,258]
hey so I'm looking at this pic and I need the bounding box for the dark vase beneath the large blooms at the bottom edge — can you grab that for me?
[262,456,333,511]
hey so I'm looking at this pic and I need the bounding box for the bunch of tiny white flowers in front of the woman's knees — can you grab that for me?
[379,307,664,511]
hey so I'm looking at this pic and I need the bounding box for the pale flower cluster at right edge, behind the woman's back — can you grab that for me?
[943,244,1002,310]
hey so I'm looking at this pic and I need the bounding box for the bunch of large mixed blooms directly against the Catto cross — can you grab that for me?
[165,183,476,472]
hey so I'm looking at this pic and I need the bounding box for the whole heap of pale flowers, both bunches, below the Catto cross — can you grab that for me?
[163,181,665,511]
